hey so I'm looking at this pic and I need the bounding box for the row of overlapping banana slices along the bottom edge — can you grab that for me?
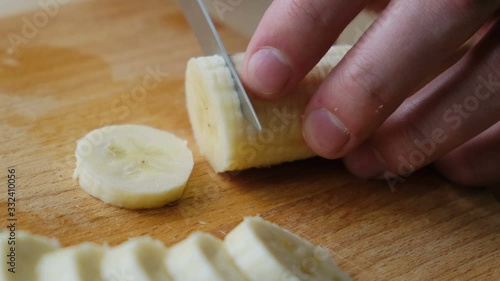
[0,217,351,281]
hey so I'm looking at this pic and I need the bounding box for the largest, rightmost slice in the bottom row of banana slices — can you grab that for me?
[224,217,351,281]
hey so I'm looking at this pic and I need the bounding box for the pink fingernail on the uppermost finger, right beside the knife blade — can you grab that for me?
[247,48,292,95]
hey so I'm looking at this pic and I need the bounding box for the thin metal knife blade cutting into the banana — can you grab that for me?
[179,0,262,131]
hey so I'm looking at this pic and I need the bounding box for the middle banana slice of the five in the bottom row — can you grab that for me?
[102,237,171,281]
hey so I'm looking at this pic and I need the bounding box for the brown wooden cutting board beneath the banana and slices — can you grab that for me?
[0,0,500,280]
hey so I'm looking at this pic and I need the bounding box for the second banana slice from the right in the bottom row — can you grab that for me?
[165,232,248,281]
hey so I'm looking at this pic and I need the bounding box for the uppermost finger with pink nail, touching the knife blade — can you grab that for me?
[241,0,372,98]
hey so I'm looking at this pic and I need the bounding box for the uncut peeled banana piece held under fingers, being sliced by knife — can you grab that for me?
[185,45,350,172]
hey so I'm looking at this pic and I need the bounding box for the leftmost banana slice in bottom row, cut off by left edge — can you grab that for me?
[0,231,60,281]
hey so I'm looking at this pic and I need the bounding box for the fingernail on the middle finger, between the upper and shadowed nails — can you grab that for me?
[304,108,350,158]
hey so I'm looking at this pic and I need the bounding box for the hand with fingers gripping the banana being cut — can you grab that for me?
[241,0,500,186]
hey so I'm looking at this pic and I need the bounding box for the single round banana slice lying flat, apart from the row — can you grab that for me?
[74,125,194,209]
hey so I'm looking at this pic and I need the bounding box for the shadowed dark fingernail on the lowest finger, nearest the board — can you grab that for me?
[343,144,386,179]
